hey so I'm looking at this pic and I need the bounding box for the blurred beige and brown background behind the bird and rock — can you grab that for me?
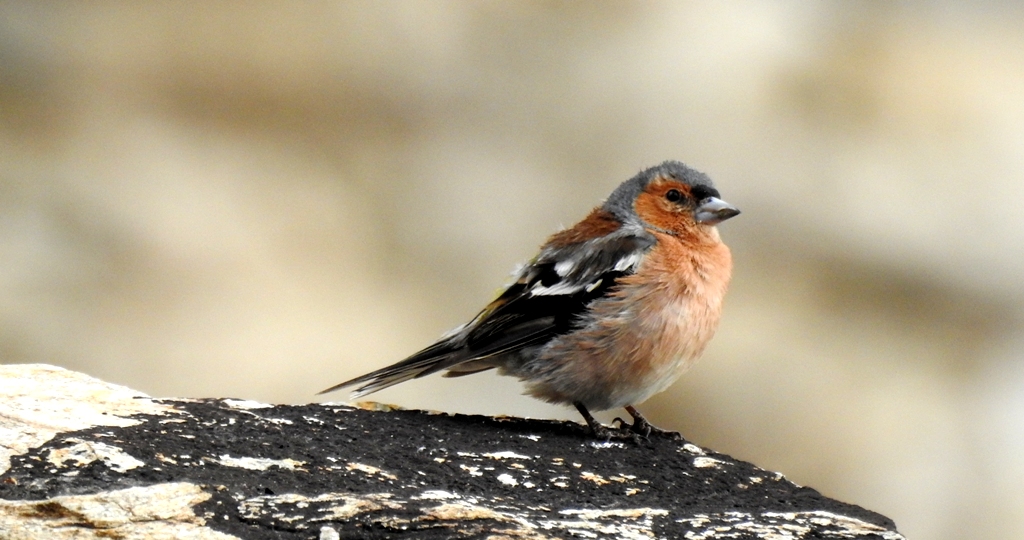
[0,1,1024,540]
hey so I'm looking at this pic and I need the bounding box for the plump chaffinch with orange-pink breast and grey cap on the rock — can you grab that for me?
[321,161,739,439]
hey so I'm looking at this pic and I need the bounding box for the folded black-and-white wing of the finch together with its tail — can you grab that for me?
[321,224,654,397]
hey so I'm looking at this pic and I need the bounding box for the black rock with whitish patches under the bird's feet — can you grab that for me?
[0,366,903,540]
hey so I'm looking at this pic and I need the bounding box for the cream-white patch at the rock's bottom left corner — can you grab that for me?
[0,483,239,540]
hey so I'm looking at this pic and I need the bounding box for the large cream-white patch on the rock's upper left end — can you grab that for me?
[0,364,178,473]
